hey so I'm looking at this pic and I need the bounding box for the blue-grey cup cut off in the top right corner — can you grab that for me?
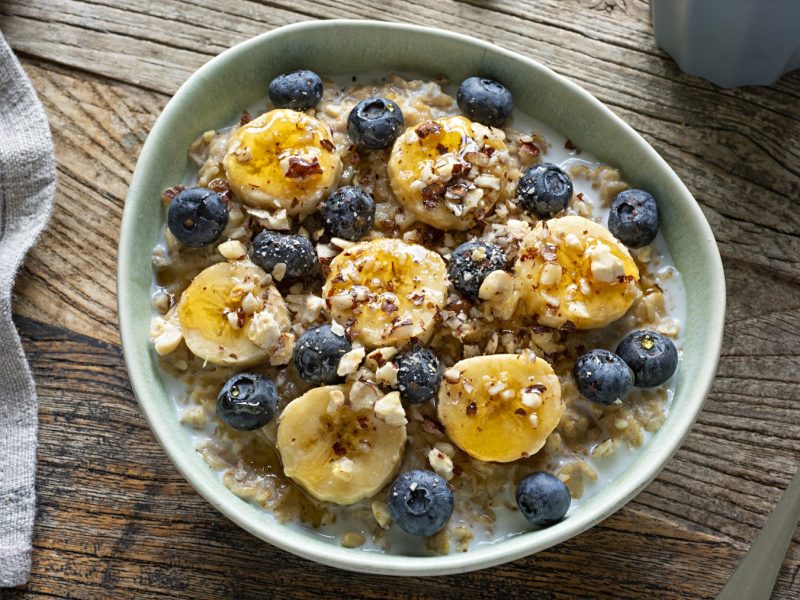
[650,0,800,88]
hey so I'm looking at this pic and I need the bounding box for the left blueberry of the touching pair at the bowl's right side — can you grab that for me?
[573,349,633,406]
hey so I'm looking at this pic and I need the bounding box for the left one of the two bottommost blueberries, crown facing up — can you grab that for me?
[388,469,455,537]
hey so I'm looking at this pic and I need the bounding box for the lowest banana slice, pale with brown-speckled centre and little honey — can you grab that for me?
[277,385,406,504]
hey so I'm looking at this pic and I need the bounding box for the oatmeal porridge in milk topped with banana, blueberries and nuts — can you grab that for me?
[150,71,684,554]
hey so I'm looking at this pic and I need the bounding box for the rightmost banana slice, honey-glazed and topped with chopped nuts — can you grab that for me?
[515,216,639,329]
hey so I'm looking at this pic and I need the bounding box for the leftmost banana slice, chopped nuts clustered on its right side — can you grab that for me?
[178,261,291,366]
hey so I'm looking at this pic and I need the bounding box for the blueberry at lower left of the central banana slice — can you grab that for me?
[294,325,351,385]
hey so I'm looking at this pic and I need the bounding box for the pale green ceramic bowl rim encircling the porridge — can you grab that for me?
[117,19,725,576]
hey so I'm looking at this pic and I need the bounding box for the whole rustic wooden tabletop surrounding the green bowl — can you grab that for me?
[0,0,800,599]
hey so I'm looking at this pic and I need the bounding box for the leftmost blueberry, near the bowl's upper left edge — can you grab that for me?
[167,188,228,248]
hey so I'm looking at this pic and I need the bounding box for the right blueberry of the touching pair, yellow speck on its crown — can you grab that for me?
[617,331,678,387]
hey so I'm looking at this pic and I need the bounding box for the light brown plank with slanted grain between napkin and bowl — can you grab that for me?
[14,62,167,342]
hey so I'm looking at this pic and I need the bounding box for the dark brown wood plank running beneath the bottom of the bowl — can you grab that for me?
[7,319,800,599]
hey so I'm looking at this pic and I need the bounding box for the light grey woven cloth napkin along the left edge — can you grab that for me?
[0,33,56,588]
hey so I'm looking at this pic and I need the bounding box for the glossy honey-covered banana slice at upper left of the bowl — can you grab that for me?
[223,109,342,215]
